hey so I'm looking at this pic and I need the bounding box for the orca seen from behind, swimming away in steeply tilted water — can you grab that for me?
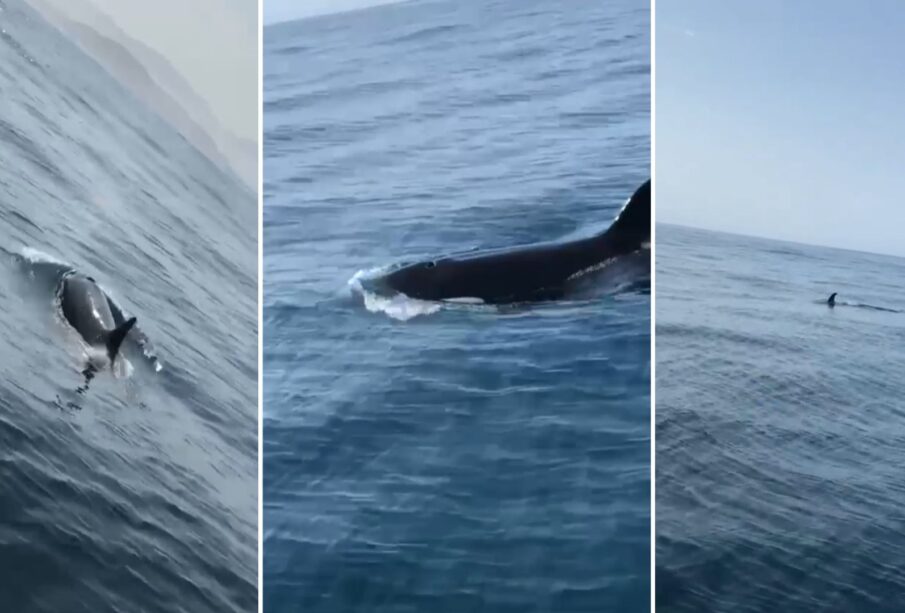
[60,273,136,365]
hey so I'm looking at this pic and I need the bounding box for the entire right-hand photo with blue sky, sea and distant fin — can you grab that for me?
[656,0,905,613]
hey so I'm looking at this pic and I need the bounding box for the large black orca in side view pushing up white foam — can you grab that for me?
[376,179,651,304]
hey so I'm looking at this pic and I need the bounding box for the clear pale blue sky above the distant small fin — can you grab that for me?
[656,0,905,255]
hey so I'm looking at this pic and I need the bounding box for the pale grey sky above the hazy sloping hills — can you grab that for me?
[44,0,258,141]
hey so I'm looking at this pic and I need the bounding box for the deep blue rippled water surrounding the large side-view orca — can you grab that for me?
[264,0,650,613]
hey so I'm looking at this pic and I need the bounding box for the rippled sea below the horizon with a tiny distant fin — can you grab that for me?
[656,225,905,613]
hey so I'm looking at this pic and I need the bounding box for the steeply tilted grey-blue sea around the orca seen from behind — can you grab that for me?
[0,0,257,613]
